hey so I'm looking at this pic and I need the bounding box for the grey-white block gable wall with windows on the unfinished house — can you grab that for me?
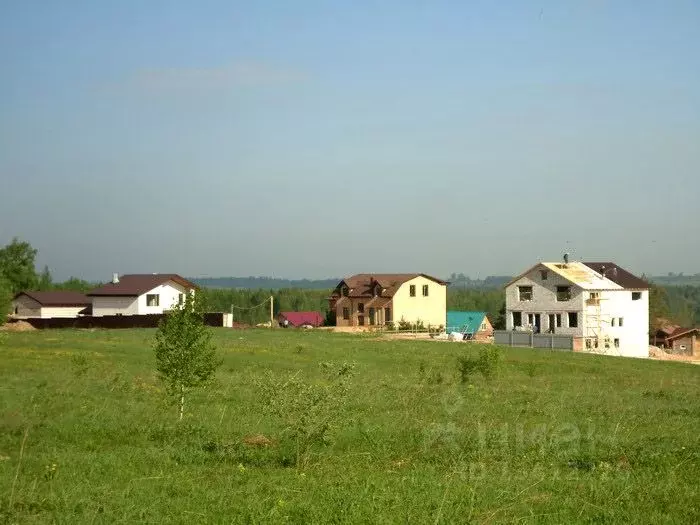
[506,266,588,337]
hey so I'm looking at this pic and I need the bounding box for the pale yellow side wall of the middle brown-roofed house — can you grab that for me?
[393,277,447,328]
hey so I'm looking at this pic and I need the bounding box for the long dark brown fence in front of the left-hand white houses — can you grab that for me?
[13,312,231,329]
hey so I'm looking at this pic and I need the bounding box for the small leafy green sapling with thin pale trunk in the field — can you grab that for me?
[153,293,221,420]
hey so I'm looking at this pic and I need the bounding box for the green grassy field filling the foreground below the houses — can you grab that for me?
[0,329,700,523]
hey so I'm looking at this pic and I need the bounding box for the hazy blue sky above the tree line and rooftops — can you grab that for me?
[0,0,700,280]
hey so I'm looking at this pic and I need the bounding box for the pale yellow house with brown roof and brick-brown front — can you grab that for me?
[329,273,447,328]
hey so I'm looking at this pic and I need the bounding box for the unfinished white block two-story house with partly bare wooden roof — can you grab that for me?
[506,261,649,357]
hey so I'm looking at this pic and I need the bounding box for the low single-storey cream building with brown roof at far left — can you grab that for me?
[12,290,90,319]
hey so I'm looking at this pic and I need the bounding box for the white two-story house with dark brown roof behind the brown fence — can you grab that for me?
[87,273,197,316]
